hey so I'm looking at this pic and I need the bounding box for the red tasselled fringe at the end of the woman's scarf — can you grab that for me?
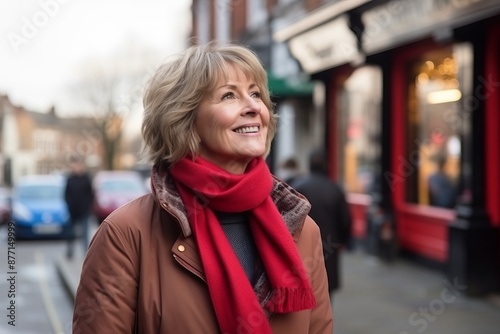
[266,288,316,313]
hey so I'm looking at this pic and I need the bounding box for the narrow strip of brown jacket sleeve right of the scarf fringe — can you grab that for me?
[302,218,333,334]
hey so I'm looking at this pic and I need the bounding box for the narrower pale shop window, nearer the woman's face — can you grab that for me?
[338,66,382,194]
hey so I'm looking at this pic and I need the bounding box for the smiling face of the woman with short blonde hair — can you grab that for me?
[195,65,270,174]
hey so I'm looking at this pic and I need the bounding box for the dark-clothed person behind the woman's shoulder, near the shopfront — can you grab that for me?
[292,150,352,297]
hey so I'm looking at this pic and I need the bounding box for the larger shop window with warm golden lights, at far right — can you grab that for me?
[406,47,463,208]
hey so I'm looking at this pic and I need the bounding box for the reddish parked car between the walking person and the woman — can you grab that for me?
[93,171,148,223]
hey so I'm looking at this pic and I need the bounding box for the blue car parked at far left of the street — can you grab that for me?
[12,175,69,239]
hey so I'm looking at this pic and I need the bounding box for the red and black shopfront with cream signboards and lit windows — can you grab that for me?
[281,0,500,294]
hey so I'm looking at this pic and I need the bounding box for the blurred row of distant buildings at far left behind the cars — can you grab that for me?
[0,95,104,187]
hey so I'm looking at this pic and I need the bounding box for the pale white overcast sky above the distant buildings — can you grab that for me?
[0,0,191,120]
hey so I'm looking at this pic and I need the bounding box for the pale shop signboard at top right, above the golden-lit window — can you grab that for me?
[362,0,500,54]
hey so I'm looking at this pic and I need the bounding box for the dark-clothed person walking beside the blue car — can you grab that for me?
[64,156,94,259]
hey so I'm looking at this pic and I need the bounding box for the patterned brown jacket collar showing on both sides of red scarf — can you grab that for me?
[151,163,311,241]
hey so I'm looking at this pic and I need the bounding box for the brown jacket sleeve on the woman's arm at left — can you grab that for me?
[73,220,139,334]
